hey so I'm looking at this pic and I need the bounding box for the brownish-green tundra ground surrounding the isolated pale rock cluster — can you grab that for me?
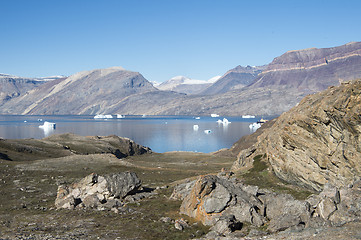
[0,152,234,239]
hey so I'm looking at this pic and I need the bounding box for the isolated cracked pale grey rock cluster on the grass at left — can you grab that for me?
[55,172,151,210]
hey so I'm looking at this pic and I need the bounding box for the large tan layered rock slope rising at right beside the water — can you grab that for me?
[233,80,361,190]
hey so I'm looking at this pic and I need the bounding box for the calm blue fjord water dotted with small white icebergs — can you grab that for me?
[0,115,266,153]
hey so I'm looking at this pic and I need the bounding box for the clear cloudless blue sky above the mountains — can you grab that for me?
[0,0,361,82]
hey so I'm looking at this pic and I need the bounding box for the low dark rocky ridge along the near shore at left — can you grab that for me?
[0,133,152,161]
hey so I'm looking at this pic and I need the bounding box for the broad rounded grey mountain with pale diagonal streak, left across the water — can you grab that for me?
[1,67,157,114]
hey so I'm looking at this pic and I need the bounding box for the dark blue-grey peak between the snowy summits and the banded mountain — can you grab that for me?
[200,66,266,95]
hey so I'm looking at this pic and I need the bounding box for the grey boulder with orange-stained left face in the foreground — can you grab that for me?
[180,175,263,225]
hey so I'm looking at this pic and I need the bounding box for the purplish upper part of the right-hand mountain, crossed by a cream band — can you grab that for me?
[250,42,361,93]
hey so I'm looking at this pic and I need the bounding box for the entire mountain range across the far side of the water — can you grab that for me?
[0,42,361,115]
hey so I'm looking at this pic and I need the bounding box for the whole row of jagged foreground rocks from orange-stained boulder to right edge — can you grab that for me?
[178,173,361,236]
